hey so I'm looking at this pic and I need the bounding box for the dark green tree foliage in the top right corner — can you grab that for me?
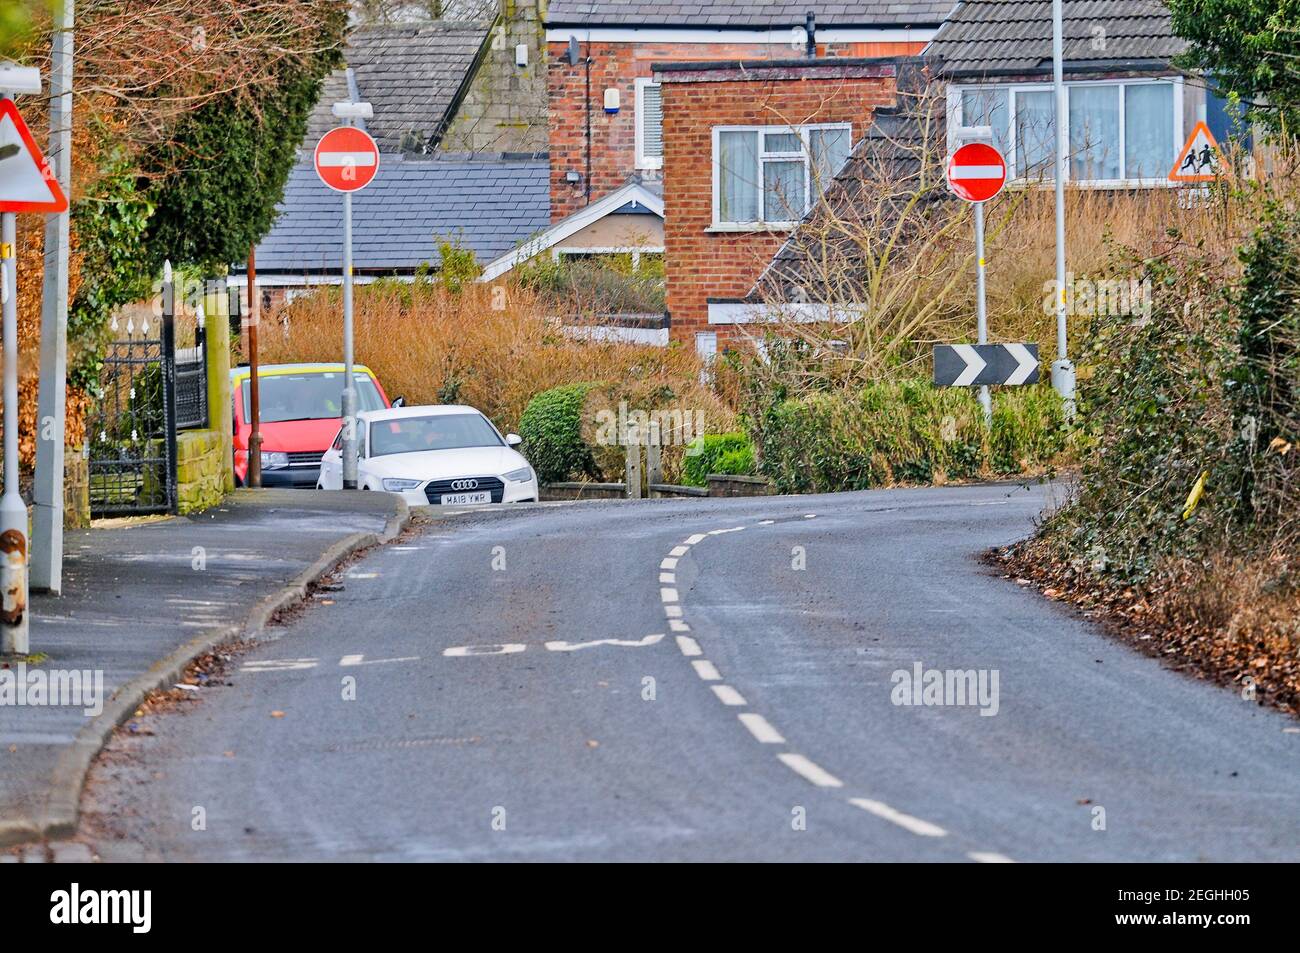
[1166,0,1300,135]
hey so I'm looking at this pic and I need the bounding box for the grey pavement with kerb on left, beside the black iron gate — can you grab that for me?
[0,490,408,842]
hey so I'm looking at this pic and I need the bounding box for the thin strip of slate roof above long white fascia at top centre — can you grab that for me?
[546,0,954,30]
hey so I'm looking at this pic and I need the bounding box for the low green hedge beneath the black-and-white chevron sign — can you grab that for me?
[755,380,1063,493]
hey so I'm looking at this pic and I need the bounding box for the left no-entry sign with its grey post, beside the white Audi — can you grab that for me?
[315,109,380,490]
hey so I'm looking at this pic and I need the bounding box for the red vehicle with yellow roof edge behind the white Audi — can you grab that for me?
[230,364,390,488]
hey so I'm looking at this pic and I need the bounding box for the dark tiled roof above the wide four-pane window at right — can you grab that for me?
[924,0,1187,75]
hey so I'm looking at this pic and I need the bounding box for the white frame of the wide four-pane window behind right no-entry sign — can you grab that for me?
[948,77,1187,189]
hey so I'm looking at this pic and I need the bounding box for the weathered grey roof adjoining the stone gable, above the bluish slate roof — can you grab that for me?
[307,21,491,152]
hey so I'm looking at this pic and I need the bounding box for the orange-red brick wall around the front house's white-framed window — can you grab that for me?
[663,70,894,347]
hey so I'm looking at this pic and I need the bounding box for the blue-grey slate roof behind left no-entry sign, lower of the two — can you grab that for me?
[257,156,551,276]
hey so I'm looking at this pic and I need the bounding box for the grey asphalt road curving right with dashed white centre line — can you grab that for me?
[85,485,1300,862]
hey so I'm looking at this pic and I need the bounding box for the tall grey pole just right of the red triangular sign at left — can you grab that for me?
[31,0,73,594]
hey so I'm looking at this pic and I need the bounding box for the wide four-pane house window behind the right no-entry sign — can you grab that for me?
[950,79,1183,185]
